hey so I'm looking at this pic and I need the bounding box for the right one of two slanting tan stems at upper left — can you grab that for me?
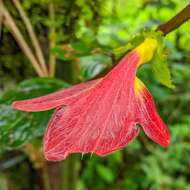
[13,0,48,75]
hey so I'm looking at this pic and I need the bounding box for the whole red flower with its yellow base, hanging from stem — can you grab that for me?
[13,39,170,161]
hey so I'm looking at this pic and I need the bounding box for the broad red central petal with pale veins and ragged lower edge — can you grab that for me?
[44,53,139,160]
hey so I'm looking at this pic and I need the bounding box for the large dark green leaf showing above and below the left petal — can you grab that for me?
[0,78,69,153]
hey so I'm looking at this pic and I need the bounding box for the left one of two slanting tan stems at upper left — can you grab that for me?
[0,2,45,77]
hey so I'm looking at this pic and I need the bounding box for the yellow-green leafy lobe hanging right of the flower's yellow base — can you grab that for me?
[151,45,175,89]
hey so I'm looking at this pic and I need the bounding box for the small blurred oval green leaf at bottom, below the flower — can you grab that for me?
[97,165,115,183]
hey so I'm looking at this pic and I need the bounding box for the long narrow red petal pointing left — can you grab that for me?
[12,79,101,112]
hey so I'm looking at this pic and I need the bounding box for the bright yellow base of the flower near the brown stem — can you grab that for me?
[135,38,158,65]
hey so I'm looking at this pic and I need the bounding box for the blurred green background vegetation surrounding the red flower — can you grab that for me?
[0,0,190,190]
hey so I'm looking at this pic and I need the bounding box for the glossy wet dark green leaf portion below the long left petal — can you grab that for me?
[0,105,52,153]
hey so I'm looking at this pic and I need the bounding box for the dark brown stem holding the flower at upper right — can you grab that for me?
[157,3,190,36]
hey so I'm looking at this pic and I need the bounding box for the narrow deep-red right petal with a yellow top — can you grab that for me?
[136,79,170,147]
